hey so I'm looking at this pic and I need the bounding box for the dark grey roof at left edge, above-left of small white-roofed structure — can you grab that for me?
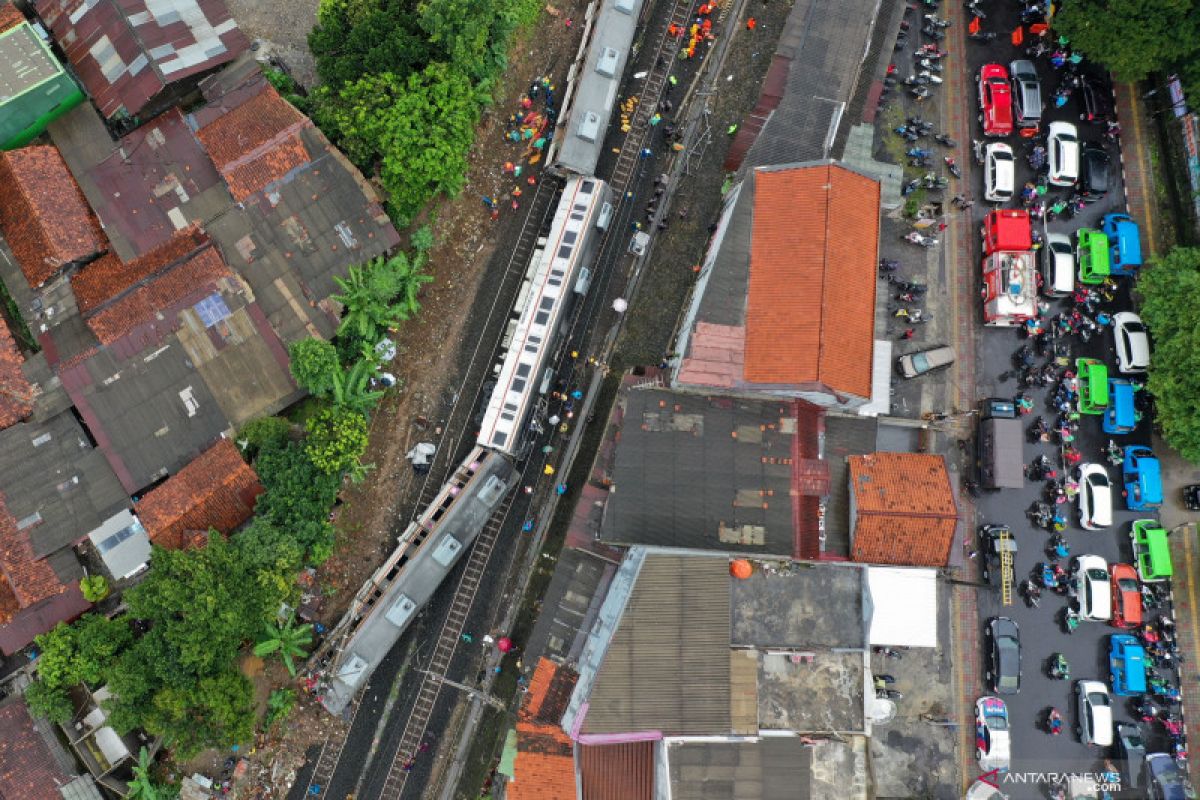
[0,413,130,558]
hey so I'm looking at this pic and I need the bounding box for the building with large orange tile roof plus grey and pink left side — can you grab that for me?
[671,161,888,409]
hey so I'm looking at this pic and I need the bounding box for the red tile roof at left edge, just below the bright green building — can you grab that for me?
[0,145,108,289]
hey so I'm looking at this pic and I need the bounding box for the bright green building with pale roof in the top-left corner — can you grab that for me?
[0,8,83,150]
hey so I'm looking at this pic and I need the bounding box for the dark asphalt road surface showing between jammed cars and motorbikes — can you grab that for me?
[966,4,1180,798]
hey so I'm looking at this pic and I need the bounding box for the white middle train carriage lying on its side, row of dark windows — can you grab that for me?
[476,178,612,457]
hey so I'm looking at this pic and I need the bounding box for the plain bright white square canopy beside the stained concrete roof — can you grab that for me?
[866,566,937,648]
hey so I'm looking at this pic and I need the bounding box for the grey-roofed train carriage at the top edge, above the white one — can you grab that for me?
[553,0,642,175]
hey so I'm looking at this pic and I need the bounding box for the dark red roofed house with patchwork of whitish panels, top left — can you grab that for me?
[32,0,250,120]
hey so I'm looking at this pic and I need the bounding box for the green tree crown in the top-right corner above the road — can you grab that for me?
[1054,0,1200,82]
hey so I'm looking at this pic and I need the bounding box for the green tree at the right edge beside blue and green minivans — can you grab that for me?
[1138,247,1200,462]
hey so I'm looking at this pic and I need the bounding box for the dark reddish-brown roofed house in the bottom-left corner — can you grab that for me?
[0,698,101,800]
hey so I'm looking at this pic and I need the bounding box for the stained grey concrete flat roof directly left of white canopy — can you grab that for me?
[731,563,866,650]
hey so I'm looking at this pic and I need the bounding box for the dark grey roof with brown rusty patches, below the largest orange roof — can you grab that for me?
[600,389,796,557]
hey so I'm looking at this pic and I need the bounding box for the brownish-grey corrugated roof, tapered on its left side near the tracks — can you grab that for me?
[582,553,731,735]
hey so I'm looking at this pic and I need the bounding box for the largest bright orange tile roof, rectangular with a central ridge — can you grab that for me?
[745,164,880,397]
